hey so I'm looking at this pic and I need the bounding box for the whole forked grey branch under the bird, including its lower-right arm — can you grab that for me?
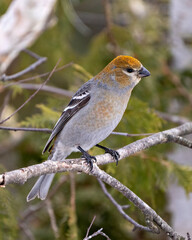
[0,122,192,240]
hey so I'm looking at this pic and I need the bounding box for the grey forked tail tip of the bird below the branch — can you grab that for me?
[27,173,55,202]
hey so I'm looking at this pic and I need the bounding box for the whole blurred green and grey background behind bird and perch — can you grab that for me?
[0,0,192,240]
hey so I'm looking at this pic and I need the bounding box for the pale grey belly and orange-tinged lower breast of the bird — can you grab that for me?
[59,94,127,151]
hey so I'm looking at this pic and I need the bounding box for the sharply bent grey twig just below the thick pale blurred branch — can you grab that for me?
[0,49,47,82]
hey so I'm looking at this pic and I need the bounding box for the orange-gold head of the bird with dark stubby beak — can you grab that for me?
[98,55,150,89]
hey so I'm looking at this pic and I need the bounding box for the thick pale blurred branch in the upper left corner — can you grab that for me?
[0,0,56,74]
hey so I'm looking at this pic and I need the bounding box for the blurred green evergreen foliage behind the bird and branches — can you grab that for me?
[0,0,192,240]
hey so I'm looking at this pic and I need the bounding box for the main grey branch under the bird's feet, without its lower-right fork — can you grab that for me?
[0,122,192,185]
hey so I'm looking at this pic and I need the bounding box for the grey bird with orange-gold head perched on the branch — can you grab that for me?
[27,56,150,201]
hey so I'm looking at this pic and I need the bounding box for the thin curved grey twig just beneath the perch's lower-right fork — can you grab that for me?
[97,179,154,233]
